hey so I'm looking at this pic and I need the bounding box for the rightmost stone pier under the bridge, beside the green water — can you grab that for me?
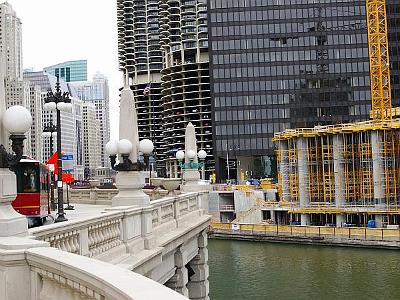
[187,231,210,300]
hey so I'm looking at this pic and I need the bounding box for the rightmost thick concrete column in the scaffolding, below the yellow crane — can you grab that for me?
[371,131,385,205]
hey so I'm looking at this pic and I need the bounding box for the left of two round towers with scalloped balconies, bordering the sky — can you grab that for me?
[117,0,165,175]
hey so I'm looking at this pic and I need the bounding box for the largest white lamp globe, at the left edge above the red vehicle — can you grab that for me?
[3,105,32,134]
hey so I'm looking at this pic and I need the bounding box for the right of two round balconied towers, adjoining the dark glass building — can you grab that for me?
[160,0,214,175]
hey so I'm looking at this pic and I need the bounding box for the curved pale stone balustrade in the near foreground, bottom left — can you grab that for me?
[0,237,187,300]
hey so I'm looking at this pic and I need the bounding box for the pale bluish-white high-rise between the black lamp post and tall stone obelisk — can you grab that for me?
[69,73,110,167]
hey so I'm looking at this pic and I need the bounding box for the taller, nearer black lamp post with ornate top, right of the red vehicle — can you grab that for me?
[44,76,72,223]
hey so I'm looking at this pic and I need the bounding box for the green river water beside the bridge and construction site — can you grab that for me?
[208,240,400,300]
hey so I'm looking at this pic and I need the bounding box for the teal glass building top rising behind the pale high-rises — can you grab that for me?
[43,60,87,82]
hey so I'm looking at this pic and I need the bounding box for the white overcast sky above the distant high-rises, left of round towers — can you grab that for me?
[6,0,122,138]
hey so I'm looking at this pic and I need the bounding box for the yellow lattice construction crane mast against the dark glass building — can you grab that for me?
[366,0,392,120]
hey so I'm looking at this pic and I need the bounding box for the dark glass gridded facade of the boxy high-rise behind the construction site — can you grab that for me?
[208,0,399,180]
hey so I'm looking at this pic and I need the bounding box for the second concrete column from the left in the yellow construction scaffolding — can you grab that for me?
[296,138,310,225]
